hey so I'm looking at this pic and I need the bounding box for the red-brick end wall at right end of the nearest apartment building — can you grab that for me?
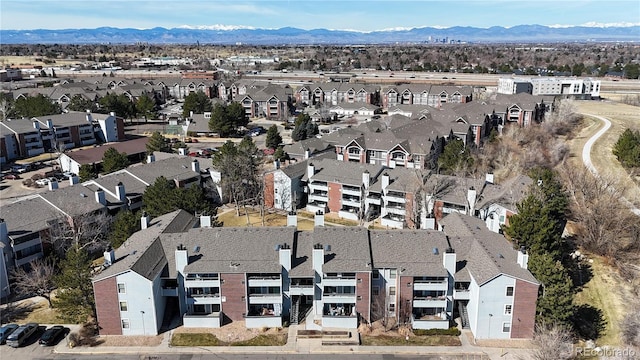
[511,279,538,339]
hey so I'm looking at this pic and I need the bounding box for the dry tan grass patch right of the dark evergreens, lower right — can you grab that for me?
[574,256,626,346]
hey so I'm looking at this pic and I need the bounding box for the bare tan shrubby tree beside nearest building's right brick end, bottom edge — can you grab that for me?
[531,324,575,360]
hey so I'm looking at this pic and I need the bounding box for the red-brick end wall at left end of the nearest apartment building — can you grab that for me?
[93,276,122,335]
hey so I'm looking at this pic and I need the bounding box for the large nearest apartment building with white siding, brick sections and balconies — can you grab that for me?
[93,211,539,339]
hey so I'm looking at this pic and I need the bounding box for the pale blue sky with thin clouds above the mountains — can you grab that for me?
[0,0,640,31]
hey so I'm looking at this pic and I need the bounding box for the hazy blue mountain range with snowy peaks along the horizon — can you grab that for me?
[0,25,640,45]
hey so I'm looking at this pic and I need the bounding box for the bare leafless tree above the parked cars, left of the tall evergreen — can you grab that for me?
[12,258,56,308]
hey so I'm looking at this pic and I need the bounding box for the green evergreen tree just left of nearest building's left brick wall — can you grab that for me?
[52,247,95,324]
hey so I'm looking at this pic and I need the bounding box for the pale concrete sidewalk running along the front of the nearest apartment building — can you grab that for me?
[54,325,529,360]
